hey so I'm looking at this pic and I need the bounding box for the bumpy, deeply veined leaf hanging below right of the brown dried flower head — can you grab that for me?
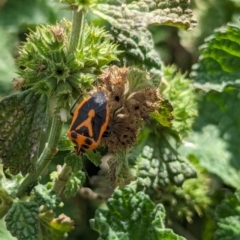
[133,133,196,191]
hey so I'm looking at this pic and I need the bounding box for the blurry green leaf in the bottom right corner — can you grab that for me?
[214,190,240,240]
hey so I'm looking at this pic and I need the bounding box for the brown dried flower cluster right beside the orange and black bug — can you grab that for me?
[98,66,163,153]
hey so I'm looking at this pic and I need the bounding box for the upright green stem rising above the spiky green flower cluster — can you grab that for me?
[69,10,85,53]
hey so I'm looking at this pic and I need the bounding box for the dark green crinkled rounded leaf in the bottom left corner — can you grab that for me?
[5,202,39,240]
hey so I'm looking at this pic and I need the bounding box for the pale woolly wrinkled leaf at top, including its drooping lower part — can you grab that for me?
[93,0,196,77]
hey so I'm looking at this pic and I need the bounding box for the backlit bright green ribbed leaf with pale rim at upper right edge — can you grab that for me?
[192,25,240,91]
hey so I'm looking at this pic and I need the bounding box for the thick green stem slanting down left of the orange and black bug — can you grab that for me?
[16,116,63,198]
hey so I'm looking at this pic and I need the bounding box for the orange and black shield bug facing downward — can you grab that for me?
[67,92,109,155]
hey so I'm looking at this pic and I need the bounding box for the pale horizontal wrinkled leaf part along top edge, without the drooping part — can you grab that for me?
[94,0,196,30]
